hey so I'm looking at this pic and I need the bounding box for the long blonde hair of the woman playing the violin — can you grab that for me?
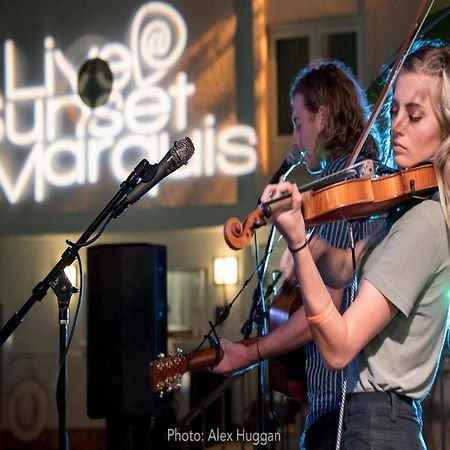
[402,45,450,229]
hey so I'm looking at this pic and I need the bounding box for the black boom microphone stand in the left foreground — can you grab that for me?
[0,159,154,450]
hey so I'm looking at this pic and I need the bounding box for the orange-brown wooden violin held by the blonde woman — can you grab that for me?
[223,163,437,250]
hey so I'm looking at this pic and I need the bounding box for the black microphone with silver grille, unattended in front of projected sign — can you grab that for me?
[112,136,195,218]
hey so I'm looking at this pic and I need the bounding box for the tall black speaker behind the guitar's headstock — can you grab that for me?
[87,244,167,419]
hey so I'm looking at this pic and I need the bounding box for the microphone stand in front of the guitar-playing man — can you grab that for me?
[241,159,305,449]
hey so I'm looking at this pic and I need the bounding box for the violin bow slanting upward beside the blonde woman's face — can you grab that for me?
[346,0,435,167]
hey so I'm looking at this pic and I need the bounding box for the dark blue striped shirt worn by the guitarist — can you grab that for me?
[305,155,384,428]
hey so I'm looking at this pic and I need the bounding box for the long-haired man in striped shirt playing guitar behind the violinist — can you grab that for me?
[215,60,383,450]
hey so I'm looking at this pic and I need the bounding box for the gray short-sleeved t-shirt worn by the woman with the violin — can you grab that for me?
[349,200,450,400]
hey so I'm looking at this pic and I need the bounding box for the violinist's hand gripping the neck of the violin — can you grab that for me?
[261,181,306,249]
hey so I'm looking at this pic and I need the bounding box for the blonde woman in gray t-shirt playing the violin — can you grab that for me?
[259,47,450,450]
